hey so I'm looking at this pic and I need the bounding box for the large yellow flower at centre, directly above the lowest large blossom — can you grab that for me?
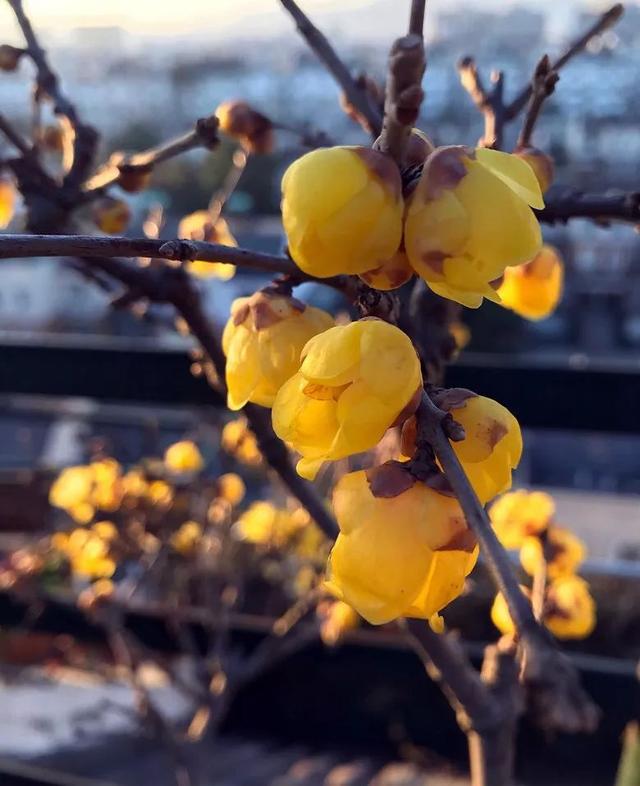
[273,319,422,479]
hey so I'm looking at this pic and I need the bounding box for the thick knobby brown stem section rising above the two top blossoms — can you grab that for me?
[375,33,426,168]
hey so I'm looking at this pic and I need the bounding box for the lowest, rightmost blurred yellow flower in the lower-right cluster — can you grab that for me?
[544,576,596,639]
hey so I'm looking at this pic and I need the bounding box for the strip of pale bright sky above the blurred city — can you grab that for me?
[5,0,624,33]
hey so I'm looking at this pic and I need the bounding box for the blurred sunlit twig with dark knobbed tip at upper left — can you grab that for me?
[84,115,219,196]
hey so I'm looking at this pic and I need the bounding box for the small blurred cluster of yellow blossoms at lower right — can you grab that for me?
[490,489,596,639]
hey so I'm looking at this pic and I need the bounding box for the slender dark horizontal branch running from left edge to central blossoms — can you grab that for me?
[0,235,302,277]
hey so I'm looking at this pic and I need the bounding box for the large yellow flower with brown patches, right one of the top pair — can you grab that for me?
[404,147,544,308]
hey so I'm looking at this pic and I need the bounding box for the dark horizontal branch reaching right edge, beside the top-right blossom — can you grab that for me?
[536,186,640,224]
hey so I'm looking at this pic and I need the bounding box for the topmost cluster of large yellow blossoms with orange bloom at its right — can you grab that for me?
[282,146,562,319]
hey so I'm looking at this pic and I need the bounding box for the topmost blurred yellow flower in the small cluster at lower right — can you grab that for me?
[489,489,556,549]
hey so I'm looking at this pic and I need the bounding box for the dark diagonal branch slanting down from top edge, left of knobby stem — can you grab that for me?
[280,0,382,136]
